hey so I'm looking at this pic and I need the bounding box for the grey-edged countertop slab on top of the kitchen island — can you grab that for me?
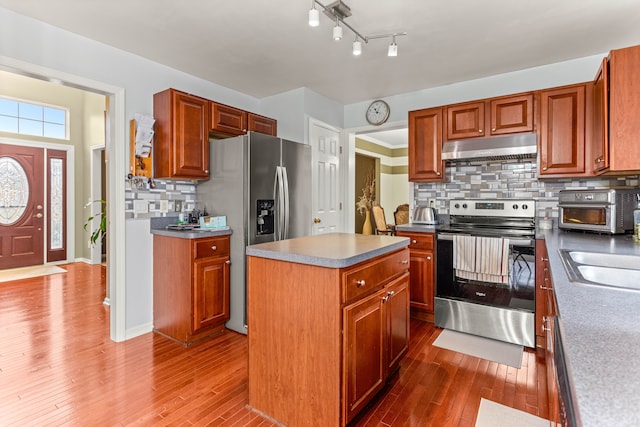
[242,233,409,268]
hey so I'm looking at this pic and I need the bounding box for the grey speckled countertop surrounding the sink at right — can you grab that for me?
[538,229,640,426]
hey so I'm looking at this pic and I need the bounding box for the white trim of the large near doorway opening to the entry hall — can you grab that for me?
[0,55,129,342]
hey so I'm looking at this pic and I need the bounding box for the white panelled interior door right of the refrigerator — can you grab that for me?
[309,119,343,234]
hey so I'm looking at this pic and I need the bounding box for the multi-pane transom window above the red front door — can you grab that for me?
[0,97,68,139]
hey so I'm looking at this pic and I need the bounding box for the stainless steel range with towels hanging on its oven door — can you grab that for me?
[435,199,536,348]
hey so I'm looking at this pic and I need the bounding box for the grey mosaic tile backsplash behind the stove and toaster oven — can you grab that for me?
[413,159,640,218]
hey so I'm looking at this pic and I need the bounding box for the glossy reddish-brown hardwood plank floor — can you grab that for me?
[0,263,548,426]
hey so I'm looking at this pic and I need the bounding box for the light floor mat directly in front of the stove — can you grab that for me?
[433,329,523,368]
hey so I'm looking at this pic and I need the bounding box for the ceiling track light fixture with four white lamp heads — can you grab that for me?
[309,0,407,56]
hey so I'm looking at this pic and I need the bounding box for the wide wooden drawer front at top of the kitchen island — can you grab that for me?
[342,249,409,302]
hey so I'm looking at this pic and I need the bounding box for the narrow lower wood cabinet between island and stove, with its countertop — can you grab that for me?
[396,231,435,322]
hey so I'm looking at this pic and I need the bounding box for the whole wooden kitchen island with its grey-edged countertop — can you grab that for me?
[247,233,409,427]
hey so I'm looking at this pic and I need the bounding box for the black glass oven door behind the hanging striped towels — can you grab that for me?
[436,233,535,312]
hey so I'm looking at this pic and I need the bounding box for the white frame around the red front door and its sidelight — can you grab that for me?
[0,137,76,265]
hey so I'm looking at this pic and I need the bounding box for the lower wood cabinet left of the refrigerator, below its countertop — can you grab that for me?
[153,235,231,345]
